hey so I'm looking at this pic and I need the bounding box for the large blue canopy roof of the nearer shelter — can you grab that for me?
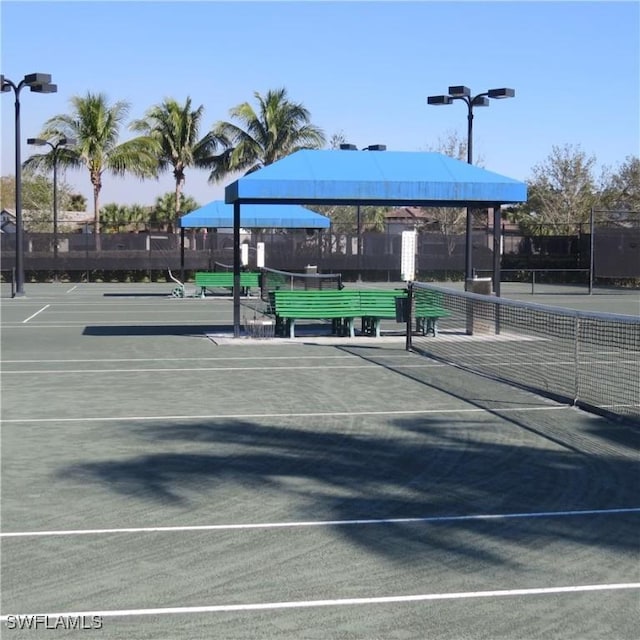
[225,150,527,207]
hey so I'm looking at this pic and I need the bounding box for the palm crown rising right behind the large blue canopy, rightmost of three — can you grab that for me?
[208,88,325,182]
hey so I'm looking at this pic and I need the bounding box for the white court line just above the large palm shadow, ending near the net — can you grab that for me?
[0,404,573,424]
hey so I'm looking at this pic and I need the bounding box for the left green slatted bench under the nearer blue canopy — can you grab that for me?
[270,289,361,338]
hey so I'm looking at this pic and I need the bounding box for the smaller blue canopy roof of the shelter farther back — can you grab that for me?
[179,200,331,229]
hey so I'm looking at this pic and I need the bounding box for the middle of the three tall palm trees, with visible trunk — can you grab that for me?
[131,97,217,231]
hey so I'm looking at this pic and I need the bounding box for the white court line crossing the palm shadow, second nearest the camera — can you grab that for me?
[0,507,640,538]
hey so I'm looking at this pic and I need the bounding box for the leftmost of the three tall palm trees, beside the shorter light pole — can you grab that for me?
[25,93,158,238]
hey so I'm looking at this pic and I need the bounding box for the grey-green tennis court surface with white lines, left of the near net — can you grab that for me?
[0,283,640,640]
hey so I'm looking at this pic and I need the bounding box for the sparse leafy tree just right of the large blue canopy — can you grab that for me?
[510,145,598,235]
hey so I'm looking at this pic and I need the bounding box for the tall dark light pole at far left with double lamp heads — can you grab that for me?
[0,73,58,297]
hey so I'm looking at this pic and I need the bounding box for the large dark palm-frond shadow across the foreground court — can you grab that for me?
[60,404,638,570]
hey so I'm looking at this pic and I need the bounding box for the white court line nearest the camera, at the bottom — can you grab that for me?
[0,582,640,621]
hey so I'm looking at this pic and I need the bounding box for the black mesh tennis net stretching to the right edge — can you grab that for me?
[407,282,640,421]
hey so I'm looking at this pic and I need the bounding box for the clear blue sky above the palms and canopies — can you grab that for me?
[0,0,640,207]
